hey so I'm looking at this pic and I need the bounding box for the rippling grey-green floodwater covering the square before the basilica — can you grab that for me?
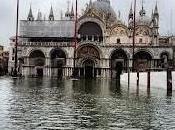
[0,77,175,130]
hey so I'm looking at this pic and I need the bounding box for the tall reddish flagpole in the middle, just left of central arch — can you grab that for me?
[73,0,78,77]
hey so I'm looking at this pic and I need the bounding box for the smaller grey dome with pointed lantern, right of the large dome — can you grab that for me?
[136,7,151,26]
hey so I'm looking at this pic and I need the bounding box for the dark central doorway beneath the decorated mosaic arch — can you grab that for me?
[83,59,96,79]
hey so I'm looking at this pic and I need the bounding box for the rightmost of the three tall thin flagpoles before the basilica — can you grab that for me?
[132,0,137,71]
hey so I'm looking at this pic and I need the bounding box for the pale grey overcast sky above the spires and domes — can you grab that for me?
[0,0,175,46]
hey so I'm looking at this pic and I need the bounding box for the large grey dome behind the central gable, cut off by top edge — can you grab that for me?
[92,0,117,22]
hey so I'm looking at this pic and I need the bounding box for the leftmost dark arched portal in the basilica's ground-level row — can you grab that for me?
[29,50,45,77]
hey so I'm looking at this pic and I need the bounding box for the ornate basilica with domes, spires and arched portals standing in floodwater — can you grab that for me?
[9,0,173,78]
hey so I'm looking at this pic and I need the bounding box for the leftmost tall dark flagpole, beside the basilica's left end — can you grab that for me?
[13,0,19,77]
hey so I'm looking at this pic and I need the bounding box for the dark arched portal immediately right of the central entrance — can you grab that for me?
[110,49,128,79]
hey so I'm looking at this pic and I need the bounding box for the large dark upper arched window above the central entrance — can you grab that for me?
[78,22,103,41]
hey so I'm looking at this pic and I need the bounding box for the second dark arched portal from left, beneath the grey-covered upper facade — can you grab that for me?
[50,49,66,79]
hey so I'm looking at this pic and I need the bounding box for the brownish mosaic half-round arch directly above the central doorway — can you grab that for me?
[76,44,102,59]
